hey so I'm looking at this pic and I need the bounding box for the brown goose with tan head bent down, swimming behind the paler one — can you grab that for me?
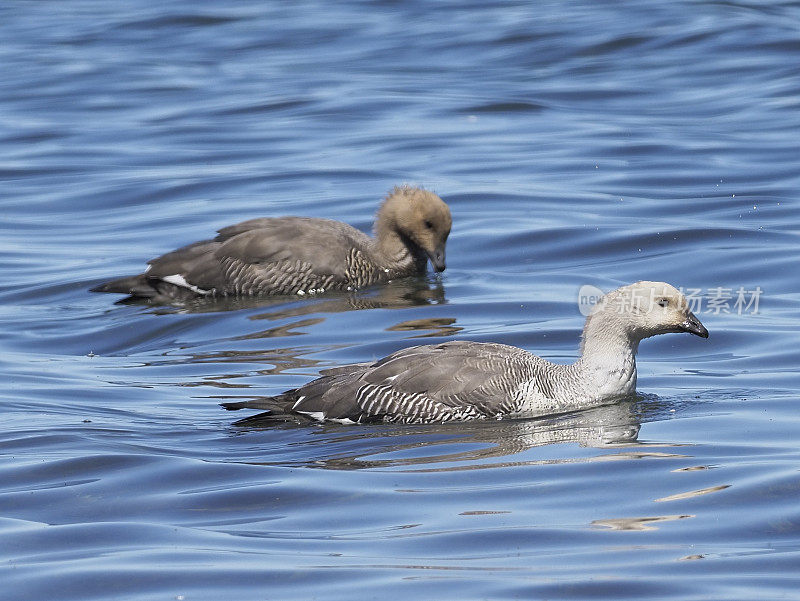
[92,186,452,302]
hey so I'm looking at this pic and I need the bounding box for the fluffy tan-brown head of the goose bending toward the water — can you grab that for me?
[375,186,453,271]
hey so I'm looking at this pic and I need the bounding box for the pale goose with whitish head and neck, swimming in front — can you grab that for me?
[222,282,708,423]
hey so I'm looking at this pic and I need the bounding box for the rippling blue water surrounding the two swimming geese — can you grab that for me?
[0,0,800,601]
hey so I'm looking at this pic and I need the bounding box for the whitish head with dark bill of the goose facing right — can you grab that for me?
[587,282,708,340]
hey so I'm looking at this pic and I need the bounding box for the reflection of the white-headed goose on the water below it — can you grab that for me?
[223,395,692,472]
